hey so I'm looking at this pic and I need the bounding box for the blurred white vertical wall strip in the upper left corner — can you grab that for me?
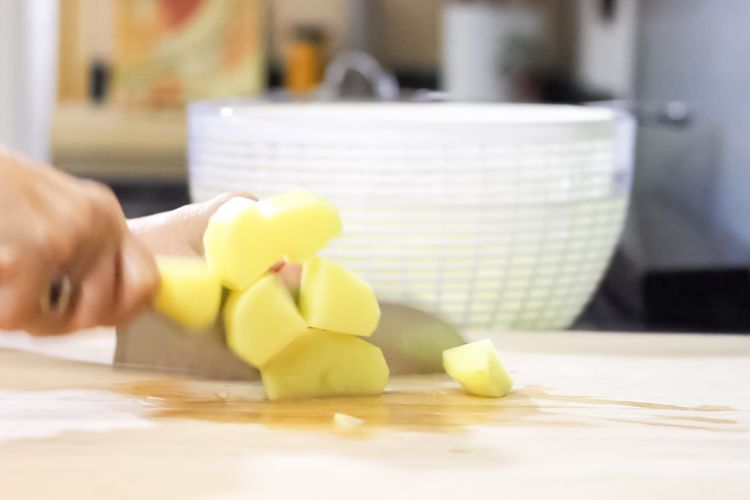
[0,0,57,161]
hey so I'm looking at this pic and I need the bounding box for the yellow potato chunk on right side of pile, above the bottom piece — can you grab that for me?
[299,257,380,337]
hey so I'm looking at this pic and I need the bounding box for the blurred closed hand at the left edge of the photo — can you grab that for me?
[0,150,159,334]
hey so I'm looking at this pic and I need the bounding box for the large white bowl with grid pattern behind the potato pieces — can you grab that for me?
[189,101,633,329]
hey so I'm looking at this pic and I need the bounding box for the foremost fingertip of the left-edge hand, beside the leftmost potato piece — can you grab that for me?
[115,235,159,325]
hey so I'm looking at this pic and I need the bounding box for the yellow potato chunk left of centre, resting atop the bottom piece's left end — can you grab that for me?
[224,272,307,368]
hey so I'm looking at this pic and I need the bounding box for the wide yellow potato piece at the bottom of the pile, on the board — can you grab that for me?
[261,328,388,400]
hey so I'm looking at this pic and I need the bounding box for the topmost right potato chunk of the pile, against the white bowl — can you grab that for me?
[267,191,341,264]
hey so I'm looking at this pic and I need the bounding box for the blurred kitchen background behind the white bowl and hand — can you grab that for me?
[0,0,750,332]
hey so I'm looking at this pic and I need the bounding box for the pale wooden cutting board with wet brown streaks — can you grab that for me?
[0,331,750,500]
